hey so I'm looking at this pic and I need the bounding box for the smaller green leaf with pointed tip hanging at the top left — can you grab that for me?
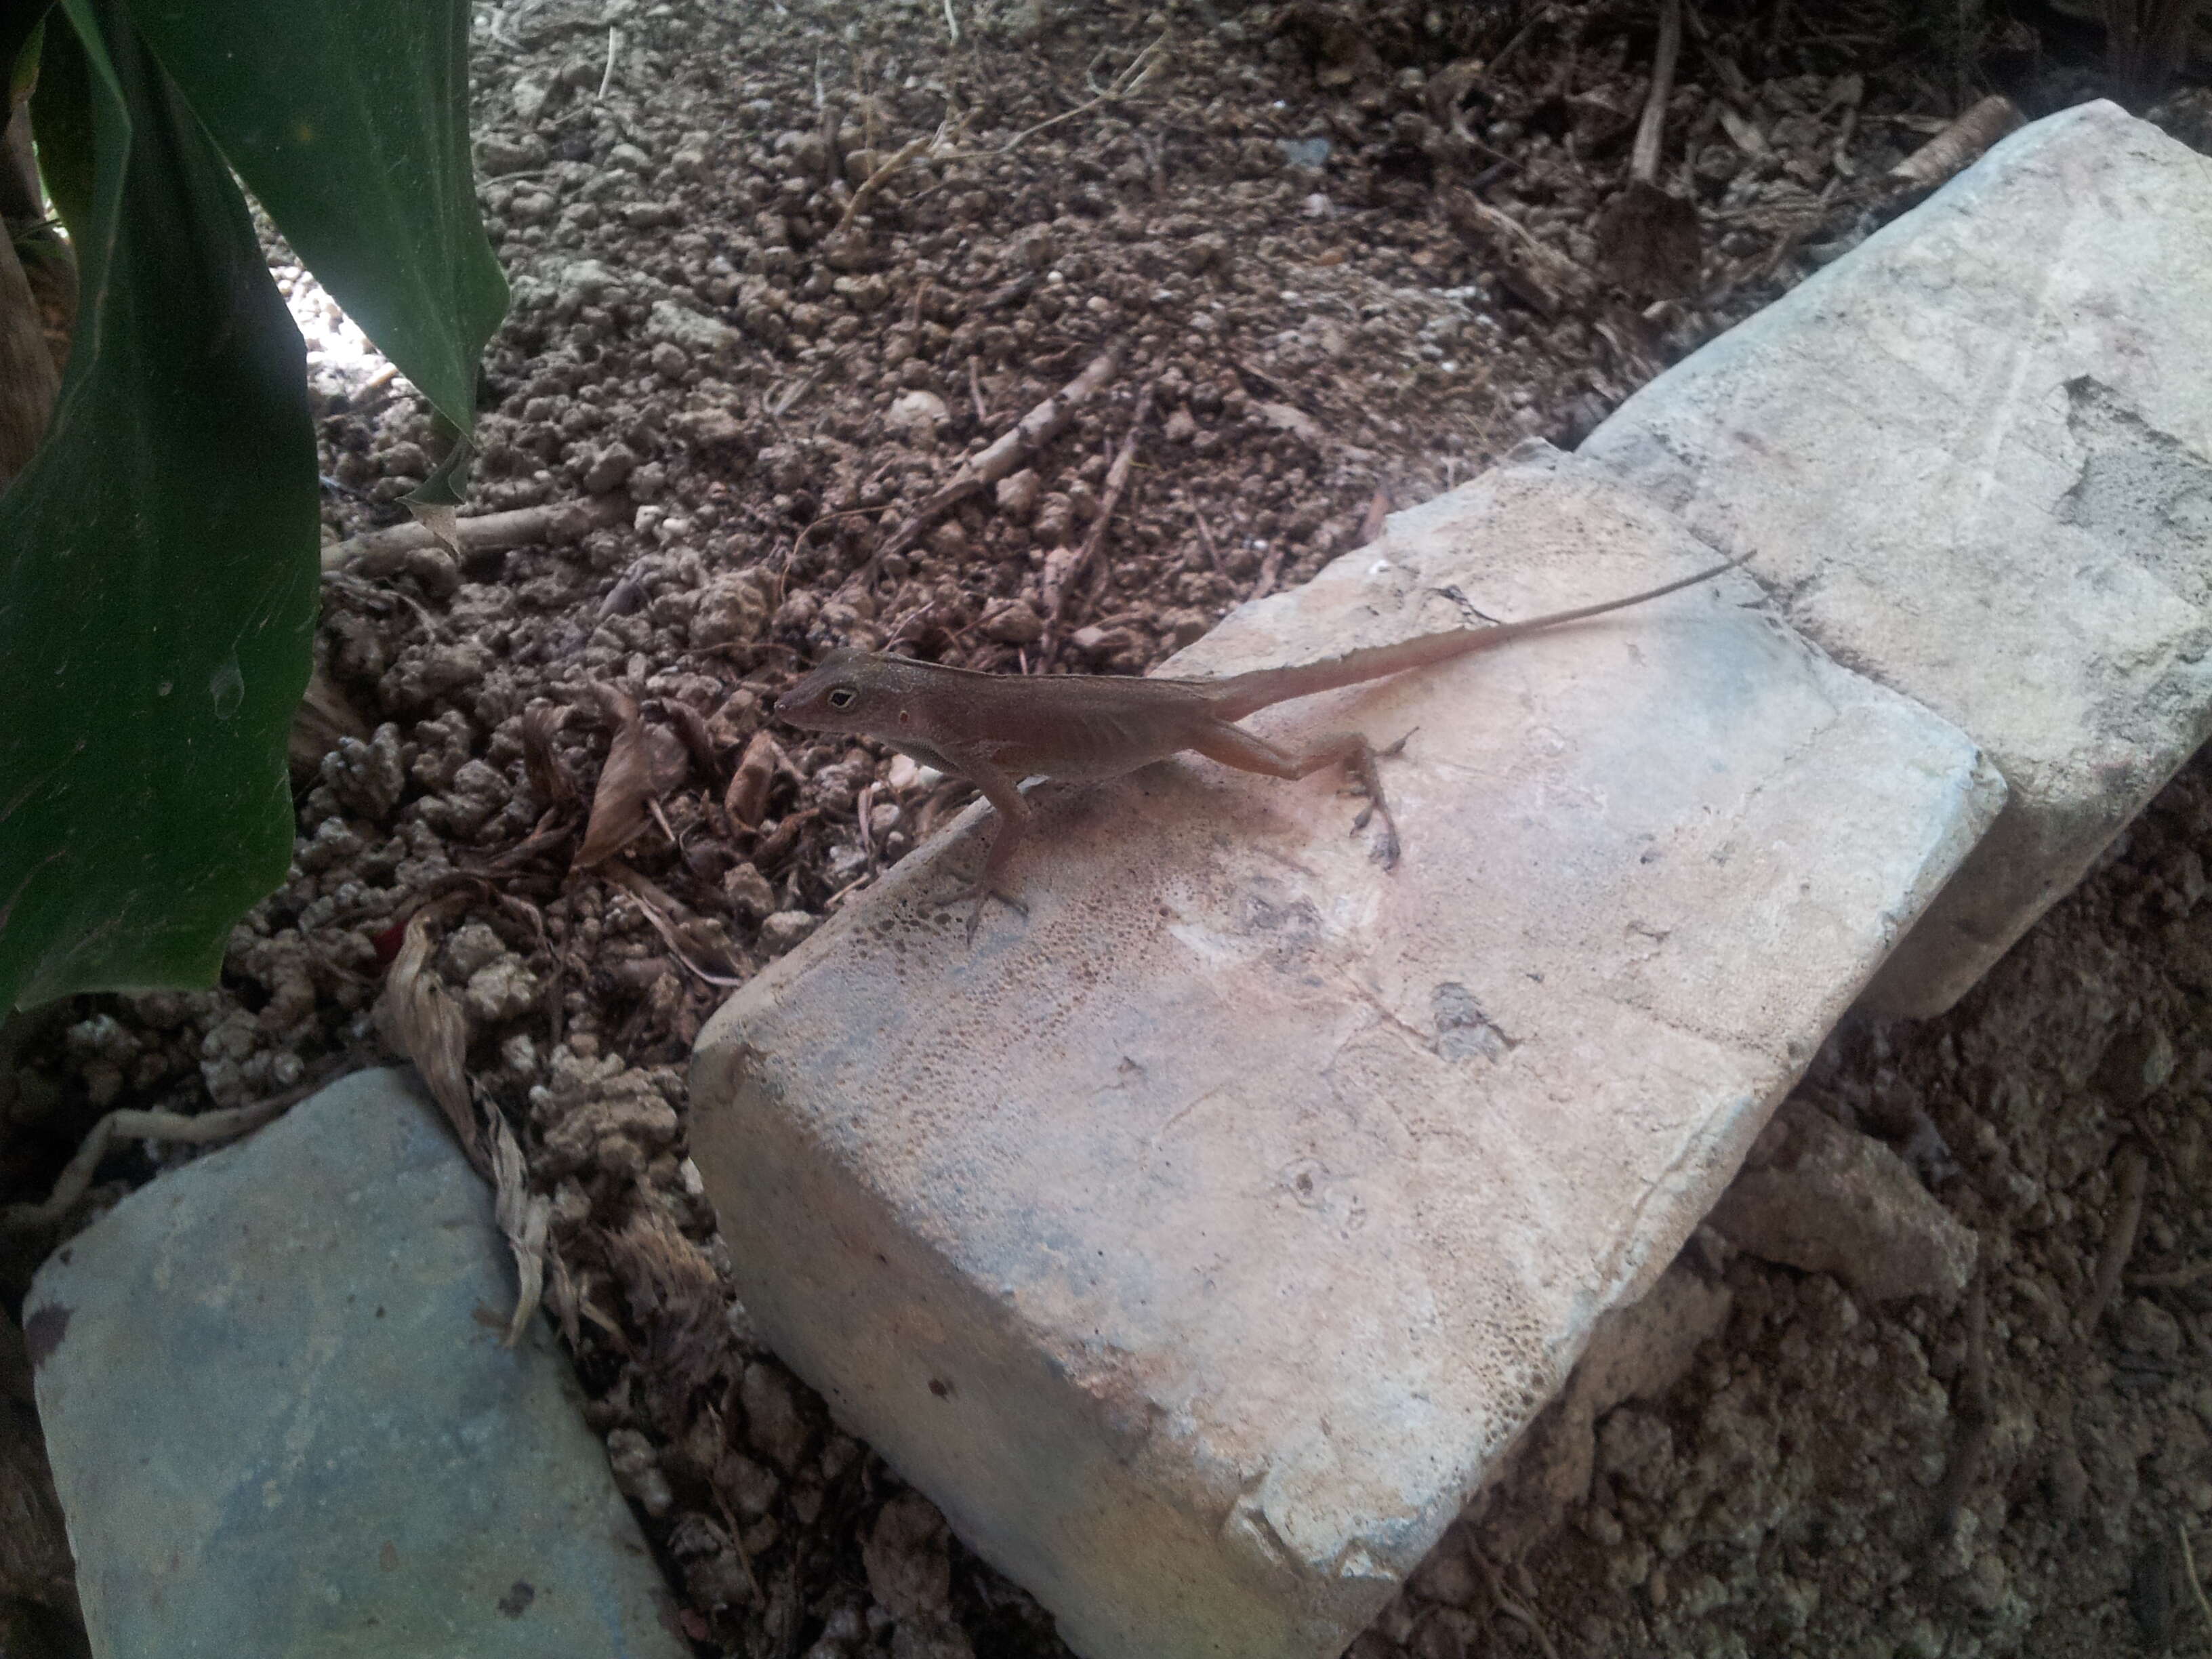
[128,0,506,434]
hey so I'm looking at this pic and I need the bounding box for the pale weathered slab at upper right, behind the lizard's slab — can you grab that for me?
[1582,104,2212,1015]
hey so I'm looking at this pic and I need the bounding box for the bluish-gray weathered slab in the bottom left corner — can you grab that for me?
[24,1071,690,1659]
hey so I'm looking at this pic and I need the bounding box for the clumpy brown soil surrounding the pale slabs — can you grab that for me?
[0,0,2212,1659]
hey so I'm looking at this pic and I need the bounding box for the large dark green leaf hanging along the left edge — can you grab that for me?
[0,0,319,1008]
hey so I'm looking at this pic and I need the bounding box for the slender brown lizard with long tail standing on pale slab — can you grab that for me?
[777,558,1743,940]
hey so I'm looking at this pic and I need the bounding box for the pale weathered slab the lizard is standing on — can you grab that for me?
[693,451,2002,1659]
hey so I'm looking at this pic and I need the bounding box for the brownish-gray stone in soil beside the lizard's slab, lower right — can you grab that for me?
[1712,1099,1975,1303]
